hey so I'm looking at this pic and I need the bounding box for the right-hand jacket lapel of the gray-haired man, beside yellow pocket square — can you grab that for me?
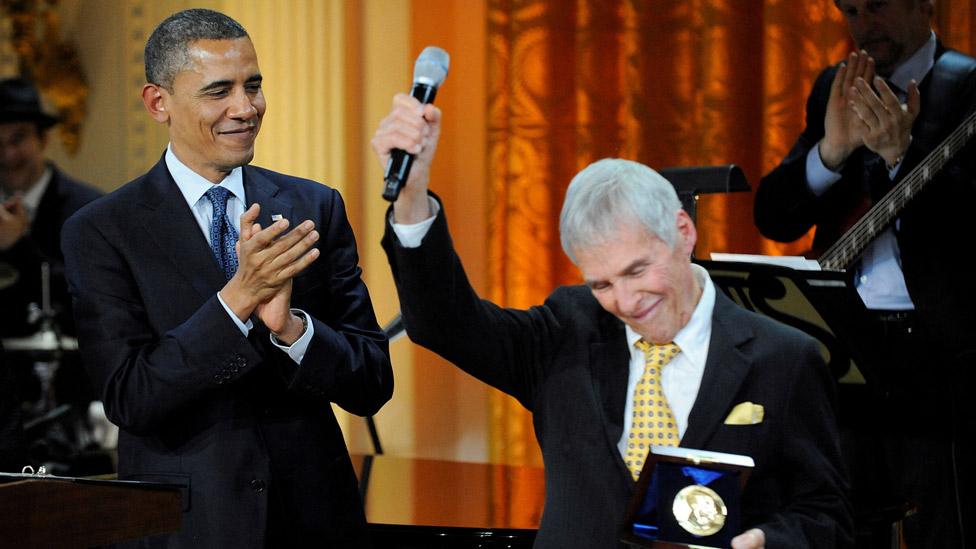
[681,294,753,448]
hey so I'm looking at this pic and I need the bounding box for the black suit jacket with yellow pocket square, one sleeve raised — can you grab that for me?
[383,202,852,549]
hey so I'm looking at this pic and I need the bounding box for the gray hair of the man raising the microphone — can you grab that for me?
[559,158,681,263]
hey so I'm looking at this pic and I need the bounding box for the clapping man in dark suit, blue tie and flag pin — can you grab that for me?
[64,9,393,547]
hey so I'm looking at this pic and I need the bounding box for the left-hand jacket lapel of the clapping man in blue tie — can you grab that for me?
[140,160,226,299]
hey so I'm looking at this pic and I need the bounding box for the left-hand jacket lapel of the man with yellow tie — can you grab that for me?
[590,314,630,478]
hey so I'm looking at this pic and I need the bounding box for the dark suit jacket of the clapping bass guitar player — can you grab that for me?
[754,44,976,354]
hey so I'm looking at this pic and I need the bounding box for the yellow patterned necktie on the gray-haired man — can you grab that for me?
[625,339,681,480]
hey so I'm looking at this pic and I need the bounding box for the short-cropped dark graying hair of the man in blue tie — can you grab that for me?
[143,8,248,90]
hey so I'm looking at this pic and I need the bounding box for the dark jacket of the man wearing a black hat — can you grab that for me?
[0,164,102,337]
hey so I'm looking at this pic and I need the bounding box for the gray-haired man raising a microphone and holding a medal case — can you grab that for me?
[373,94,851,548]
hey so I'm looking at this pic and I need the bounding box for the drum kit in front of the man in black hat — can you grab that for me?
[0,263,114,475]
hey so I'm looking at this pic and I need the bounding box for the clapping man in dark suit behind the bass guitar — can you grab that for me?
[755,0,976,547]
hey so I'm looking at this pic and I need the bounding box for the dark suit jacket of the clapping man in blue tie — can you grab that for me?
[64,156,393,548]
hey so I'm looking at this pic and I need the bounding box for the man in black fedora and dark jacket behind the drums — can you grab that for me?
[0,78,101,338]
